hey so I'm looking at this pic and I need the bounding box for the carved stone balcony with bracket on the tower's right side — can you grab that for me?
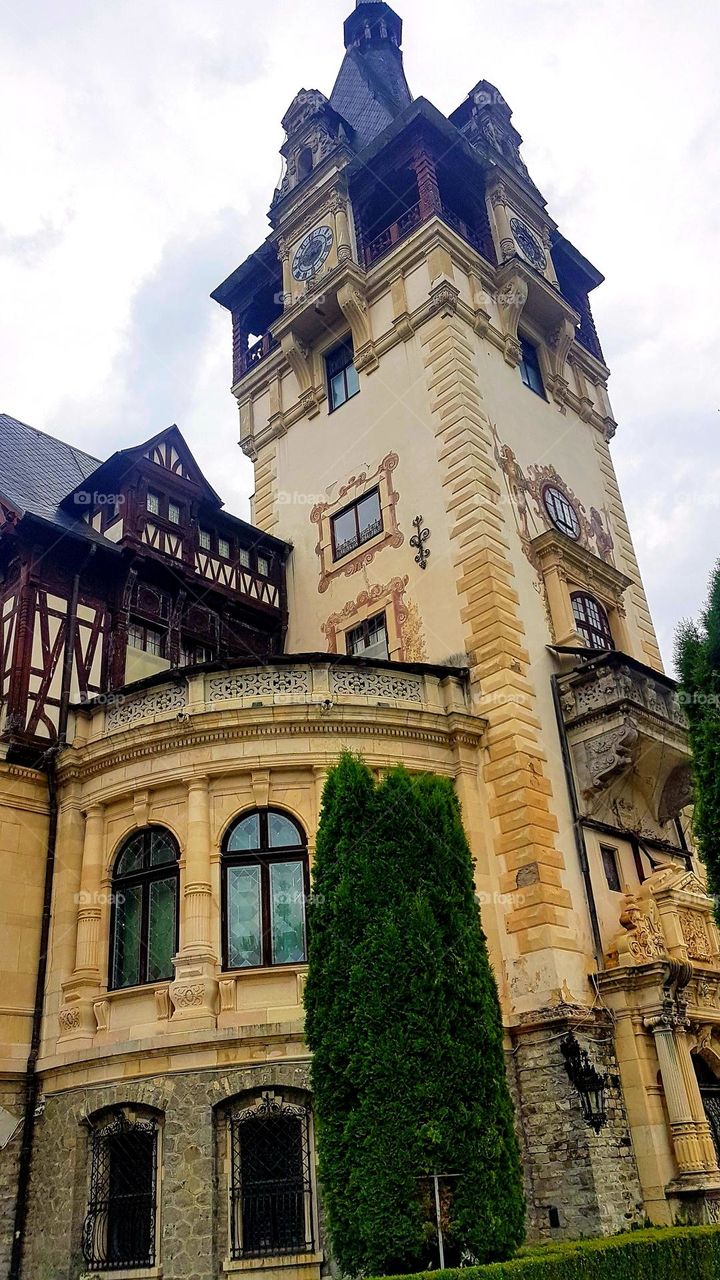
[559,653,691,838]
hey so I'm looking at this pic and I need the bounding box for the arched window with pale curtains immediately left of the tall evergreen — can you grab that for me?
[223,809,309,969]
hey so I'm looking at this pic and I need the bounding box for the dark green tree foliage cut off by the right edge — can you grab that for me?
[676,564,720,915]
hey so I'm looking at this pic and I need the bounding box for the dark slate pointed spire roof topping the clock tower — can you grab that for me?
[331,0,413,147]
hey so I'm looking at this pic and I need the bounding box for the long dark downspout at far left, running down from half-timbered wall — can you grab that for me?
[8,547,95,1280]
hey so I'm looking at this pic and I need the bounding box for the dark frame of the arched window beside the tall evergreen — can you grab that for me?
[220,805,310,973]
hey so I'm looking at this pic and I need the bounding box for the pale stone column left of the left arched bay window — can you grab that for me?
[58,804,109,1042]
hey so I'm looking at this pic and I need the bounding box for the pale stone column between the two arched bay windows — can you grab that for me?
[170,777,218,1029]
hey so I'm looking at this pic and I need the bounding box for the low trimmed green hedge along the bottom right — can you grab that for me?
[368,1226,720,1280]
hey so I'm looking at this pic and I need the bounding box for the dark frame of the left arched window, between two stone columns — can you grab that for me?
[108,823,181,991]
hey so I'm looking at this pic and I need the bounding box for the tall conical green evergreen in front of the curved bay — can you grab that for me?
[305,755,524,1275]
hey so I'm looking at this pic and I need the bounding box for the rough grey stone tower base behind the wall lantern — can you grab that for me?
[510,1009,644,1240]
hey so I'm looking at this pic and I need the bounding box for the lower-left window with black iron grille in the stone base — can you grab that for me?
[82,1107,159,1271]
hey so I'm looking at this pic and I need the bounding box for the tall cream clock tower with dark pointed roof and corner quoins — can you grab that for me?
[207,0,720,1234]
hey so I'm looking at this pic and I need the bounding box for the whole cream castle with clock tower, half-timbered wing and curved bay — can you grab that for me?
[0,0,720,1280]
